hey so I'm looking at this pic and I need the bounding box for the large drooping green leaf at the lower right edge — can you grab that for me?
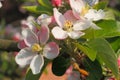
[88,38,118,77]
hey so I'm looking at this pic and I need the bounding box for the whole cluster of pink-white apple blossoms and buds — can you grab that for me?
[15,0,105,74]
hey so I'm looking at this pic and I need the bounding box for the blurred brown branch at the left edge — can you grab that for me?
[0,39,20,51]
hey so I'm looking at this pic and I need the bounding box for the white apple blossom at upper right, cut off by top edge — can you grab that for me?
[70,0,105,29]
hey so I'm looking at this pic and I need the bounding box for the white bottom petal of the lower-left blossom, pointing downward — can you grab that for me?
[30,55,44,74]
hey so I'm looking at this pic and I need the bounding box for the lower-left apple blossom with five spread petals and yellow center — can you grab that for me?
[15,26,59,74]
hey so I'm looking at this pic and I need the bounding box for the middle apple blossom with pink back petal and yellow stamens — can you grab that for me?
[52,8,90,39]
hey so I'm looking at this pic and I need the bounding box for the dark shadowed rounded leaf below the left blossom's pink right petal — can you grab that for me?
[52,56,70,76]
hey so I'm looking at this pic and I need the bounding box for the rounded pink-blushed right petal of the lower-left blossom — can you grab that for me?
[43,42,59,59]
